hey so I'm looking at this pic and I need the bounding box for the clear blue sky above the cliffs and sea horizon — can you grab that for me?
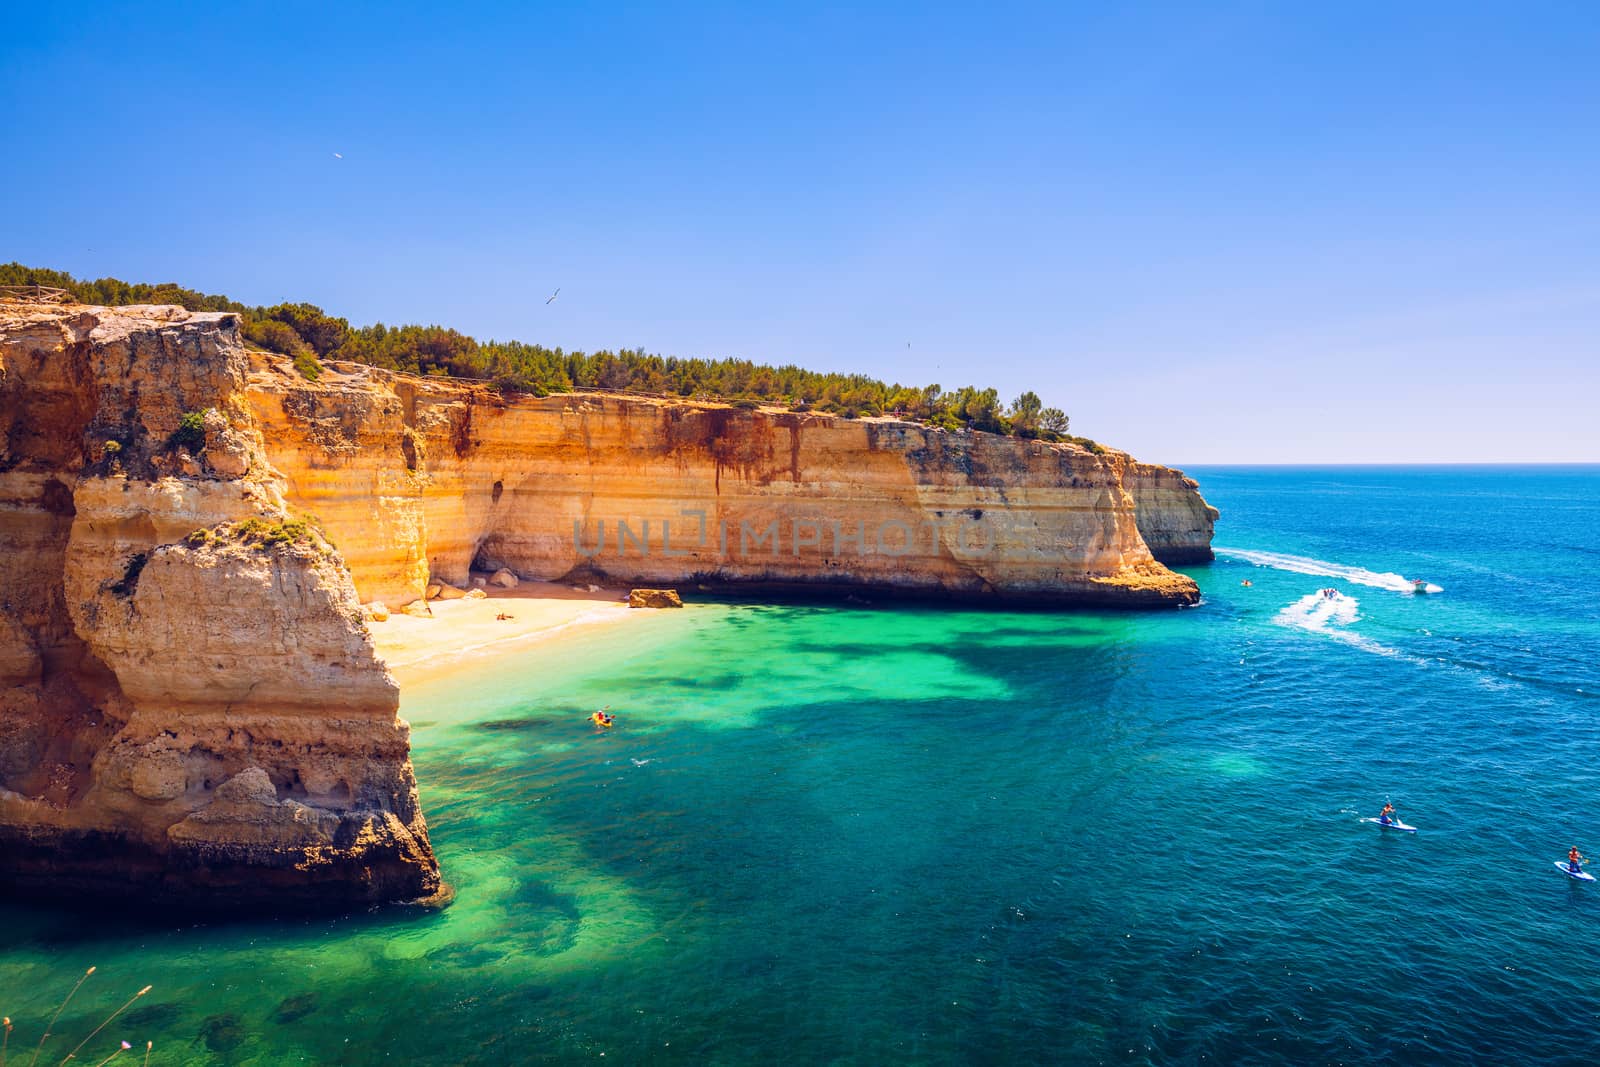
[0,0,1600,464]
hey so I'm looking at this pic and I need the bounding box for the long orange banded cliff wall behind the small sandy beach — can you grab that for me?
[250,363,1214,606]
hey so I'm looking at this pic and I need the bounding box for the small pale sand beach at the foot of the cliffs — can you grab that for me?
[368,582,640,686]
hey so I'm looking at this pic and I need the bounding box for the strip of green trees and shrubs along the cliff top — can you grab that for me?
[0,262,1101,451]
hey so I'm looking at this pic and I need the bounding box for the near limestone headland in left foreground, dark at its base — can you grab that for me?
[0,304,445,910]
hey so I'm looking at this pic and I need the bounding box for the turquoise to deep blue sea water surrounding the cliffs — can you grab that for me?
[0,467,1600,1064]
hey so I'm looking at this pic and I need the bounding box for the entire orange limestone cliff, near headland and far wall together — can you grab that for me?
[0,304,1216,909]
